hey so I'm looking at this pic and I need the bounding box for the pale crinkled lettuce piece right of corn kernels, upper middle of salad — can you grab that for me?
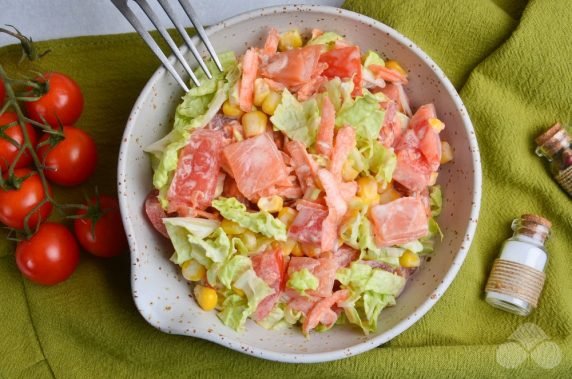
[270,89,320,146]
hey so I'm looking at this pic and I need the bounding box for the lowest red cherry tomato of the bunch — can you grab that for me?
[16,222,79,285]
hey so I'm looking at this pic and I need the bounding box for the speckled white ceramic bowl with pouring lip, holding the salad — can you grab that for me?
[118,6,481,362]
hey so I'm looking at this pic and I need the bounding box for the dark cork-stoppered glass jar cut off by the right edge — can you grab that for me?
[535,124,572,196]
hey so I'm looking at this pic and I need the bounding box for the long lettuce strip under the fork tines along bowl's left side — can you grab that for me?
[145,52,239,208]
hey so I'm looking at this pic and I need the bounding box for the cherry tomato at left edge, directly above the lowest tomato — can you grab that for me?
[0,168,52,229]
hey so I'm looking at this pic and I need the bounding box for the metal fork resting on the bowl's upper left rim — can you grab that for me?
[111,0,222,92]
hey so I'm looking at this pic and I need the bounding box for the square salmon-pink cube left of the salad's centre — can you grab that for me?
[223,133,288,201]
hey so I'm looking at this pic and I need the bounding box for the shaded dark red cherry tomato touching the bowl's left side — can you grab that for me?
[73,195,129,257]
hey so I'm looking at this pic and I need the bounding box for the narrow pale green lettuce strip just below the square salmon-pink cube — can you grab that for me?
[212,197,286,241]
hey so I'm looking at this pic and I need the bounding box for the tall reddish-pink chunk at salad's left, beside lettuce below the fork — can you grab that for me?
[167,129,224,212]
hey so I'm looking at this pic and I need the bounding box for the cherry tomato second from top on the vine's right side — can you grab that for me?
[38,126,97,186]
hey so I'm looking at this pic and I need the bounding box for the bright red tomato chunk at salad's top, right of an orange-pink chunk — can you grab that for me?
[320,46,362,96]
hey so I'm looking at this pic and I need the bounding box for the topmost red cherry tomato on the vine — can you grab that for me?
[24,72,83,128]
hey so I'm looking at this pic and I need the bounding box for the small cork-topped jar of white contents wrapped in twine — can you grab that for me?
[485,214,552,316]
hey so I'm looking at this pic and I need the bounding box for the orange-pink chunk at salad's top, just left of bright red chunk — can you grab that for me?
[260,46,322,88]
